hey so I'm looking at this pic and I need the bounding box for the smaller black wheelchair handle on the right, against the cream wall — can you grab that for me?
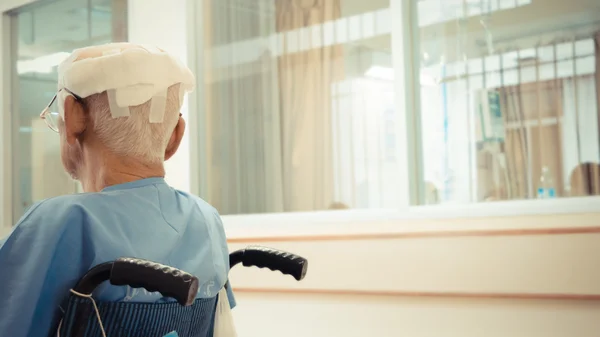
[229,246,308,281]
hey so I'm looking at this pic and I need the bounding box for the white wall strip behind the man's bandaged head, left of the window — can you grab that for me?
[127,0,190,191]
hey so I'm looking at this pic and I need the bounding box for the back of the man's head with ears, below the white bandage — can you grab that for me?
[59,85,185,179]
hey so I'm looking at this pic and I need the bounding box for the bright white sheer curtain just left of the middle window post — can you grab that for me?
[330,77,398,208]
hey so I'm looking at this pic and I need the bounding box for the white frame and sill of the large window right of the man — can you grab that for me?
[188,0,600,226]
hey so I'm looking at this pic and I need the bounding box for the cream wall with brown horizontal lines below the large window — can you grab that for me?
[225,214,600,337]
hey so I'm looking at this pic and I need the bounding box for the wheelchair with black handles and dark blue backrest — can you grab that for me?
[56,246,308,337]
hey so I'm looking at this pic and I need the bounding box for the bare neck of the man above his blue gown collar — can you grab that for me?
[79,147,165,192]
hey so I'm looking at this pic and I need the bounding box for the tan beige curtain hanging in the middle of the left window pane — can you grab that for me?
[275,0,342,211]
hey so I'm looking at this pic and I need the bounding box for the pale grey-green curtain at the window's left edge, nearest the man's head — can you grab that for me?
[201,0,284,214]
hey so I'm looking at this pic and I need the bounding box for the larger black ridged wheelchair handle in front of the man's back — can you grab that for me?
[73,257,198,306]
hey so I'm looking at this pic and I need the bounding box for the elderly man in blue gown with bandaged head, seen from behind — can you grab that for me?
[0,44,234,337]
